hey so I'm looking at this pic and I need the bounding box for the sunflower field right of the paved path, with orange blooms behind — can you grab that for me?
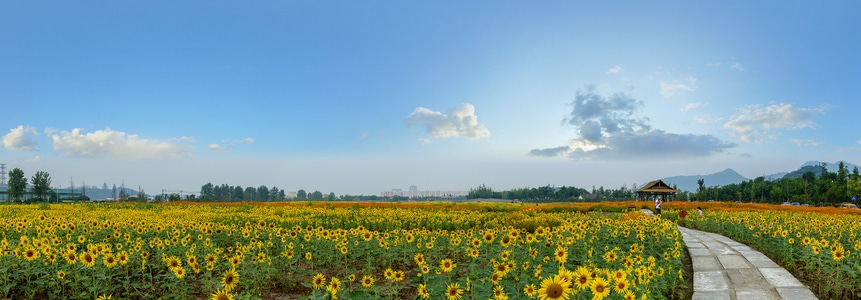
[665,202,861,299]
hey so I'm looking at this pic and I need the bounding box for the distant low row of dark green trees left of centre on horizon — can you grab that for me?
[198,183,338,202]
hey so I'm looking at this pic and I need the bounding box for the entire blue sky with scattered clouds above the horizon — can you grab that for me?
[0,1,861,195]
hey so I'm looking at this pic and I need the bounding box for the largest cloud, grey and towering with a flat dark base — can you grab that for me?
[529,86,736,161]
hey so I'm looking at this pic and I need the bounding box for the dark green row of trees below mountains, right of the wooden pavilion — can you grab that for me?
[688,162,861,205]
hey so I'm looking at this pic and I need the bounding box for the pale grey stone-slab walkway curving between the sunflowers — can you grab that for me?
[643,209,817,300]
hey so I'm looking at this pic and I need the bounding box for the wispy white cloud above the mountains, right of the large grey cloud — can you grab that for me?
[723,102,825,144]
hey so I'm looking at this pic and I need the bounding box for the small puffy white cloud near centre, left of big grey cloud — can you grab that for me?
[404,104,490,142]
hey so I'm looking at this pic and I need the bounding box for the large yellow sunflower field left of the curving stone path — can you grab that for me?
[0,202,684,299]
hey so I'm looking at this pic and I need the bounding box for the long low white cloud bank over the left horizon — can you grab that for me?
[51,128,187,159]
